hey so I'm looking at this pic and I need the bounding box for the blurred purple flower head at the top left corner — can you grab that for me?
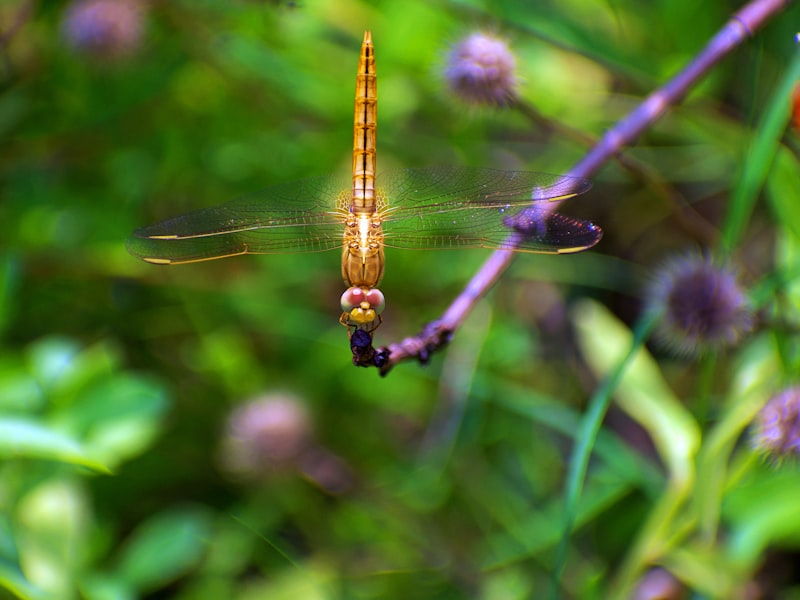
[63,0,144,60]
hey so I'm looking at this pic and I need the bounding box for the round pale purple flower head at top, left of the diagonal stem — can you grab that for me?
[444,33,517,106]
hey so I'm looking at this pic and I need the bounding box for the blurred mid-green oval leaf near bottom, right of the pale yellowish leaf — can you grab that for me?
[115,506,211,593]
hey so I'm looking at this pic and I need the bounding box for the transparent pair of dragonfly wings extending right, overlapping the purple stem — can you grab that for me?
[378,167,603,254]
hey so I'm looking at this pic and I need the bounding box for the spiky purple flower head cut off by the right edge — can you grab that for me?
[752,386,800,460]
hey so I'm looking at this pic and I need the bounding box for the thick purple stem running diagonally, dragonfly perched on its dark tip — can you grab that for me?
[372,0,792,375]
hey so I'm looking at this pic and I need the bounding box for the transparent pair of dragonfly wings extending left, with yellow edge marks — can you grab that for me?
[127,177,350,264]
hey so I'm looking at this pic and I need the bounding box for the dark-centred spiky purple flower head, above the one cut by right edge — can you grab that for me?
[646,255,752,355]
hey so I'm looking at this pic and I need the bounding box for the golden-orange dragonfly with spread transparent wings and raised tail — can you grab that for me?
[127,31,602,343]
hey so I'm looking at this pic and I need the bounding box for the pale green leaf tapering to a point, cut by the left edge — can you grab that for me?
[0,417,108,473]
